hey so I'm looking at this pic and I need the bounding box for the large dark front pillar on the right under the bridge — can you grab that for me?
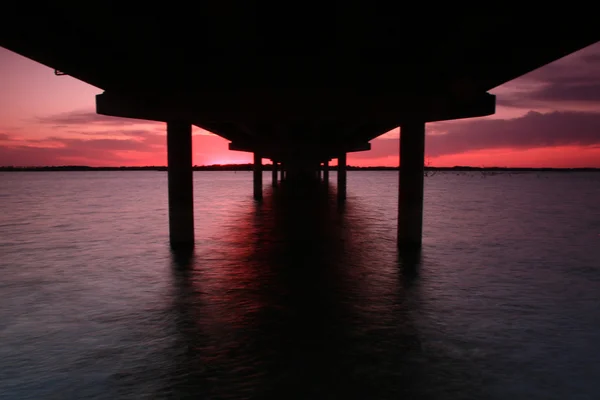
[398,121,425,248]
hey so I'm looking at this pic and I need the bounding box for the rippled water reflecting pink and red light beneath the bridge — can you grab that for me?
[0,171,600,399]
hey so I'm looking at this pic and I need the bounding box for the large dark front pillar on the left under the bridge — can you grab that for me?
[167,121,194,247]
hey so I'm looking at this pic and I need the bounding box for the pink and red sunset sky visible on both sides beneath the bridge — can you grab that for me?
[0,43,600,168]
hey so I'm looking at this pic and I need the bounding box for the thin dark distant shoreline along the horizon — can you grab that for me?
[0,164,600,172]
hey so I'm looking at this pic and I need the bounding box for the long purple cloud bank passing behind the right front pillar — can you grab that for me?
[354,111,600,158]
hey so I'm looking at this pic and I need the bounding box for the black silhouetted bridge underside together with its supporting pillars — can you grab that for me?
[0,7,600,246]
